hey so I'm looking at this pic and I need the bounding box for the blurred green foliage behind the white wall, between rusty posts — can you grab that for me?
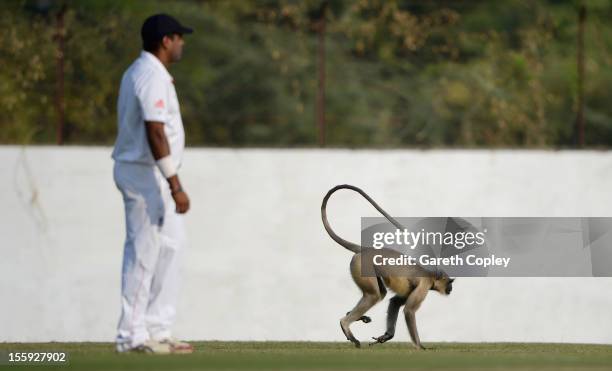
[0,0,612,148]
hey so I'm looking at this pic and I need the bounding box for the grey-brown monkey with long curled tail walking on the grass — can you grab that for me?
[321,184,454,350]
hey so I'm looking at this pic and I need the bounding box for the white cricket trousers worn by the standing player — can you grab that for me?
[113,161,186,351]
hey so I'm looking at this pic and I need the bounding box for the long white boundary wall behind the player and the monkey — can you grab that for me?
[0,146,612,343]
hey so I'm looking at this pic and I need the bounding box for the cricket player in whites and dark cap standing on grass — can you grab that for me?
[112,14,193,354]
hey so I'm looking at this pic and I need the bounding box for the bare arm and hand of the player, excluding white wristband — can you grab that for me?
[145,121,189,214]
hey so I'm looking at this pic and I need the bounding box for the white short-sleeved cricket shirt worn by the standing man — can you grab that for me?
[112,51,185,168]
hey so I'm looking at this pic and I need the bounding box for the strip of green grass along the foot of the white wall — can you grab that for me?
[0,341,612,371]
